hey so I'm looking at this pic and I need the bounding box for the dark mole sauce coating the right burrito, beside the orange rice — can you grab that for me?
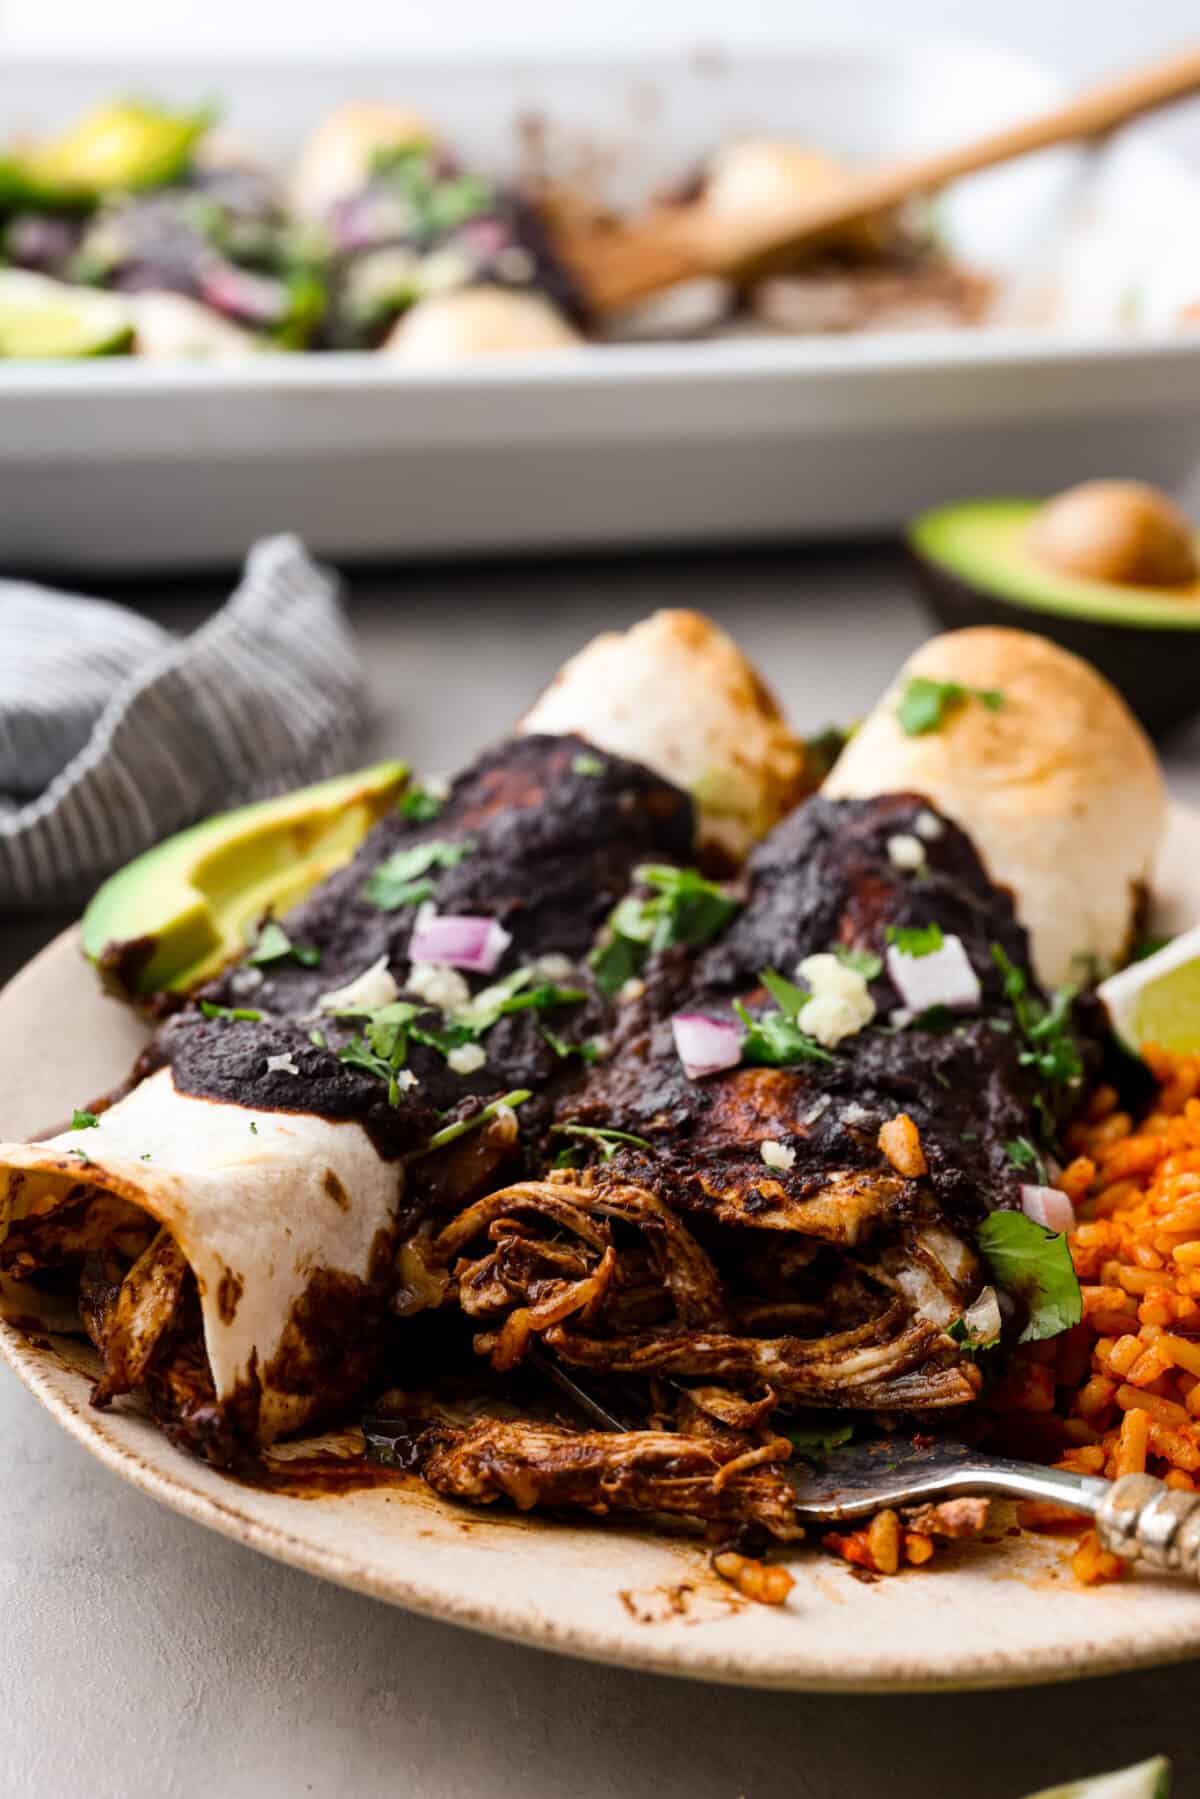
[569,793,1097,1225]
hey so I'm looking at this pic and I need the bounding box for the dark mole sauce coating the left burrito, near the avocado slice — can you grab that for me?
[137,736,694,1157]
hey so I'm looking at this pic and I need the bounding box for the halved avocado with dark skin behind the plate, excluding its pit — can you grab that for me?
[909,500,1200,734]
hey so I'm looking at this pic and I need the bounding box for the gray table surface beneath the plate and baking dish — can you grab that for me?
[0,549,1200,1799]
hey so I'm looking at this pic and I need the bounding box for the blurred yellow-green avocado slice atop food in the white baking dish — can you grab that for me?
[0,99,214,207]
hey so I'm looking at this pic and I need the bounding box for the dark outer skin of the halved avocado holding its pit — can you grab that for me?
[907,547,1200,738]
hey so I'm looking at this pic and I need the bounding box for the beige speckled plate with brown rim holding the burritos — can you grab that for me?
[0,811,1200,1691]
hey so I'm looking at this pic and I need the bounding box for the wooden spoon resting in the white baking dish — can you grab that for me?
[543,50,1200,317]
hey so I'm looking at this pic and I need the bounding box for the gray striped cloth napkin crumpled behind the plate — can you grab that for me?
[0,536,365,908]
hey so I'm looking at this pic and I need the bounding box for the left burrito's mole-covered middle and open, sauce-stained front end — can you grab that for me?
[0,615,805,1463]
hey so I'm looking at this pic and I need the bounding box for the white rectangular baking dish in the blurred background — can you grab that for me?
[0,47,1200,568]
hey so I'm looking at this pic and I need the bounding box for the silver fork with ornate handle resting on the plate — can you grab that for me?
[536,1351,1200,1580]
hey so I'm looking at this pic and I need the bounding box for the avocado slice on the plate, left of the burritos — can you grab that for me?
[81,763,408,998]
